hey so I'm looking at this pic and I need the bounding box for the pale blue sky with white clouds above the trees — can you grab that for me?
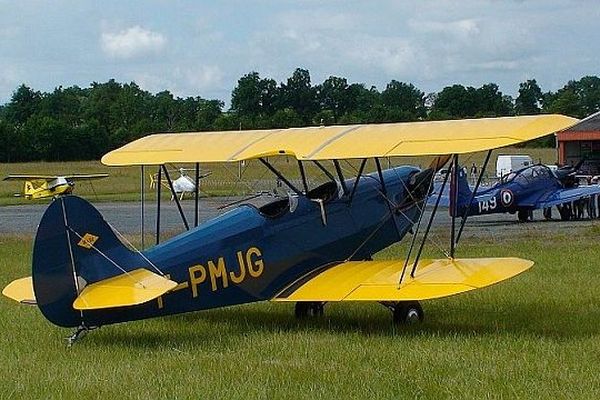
[0,0,600,104]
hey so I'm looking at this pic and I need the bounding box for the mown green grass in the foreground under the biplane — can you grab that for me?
[0,223,600,399]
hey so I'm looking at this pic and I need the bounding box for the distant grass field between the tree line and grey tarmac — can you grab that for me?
[0,148,556,205]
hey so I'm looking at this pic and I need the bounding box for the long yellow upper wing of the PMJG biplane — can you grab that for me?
[102,115,578,166]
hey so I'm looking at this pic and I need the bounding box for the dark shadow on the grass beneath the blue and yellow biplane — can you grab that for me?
[90,301,600,348]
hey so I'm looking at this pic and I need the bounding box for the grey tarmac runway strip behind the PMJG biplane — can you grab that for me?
[0,198,600,237]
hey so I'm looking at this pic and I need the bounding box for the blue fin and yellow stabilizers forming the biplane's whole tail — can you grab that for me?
[3,196,176,327]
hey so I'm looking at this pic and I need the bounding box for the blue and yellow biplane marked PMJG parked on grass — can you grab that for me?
[3,115,577,341]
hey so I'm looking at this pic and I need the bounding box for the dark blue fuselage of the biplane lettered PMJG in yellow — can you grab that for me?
[86,167,430,325]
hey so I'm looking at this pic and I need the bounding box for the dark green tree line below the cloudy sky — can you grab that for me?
[0,68,600,162]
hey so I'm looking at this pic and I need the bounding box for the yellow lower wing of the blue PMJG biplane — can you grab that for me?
[273,258,533,301]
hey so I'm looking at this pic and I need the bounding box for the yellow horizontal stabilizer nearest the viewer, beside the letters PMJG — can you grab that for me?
[73,268,177,310]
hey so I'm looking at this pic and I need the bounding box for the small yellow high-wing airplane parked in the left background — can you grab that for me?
[4,174,108,200]
